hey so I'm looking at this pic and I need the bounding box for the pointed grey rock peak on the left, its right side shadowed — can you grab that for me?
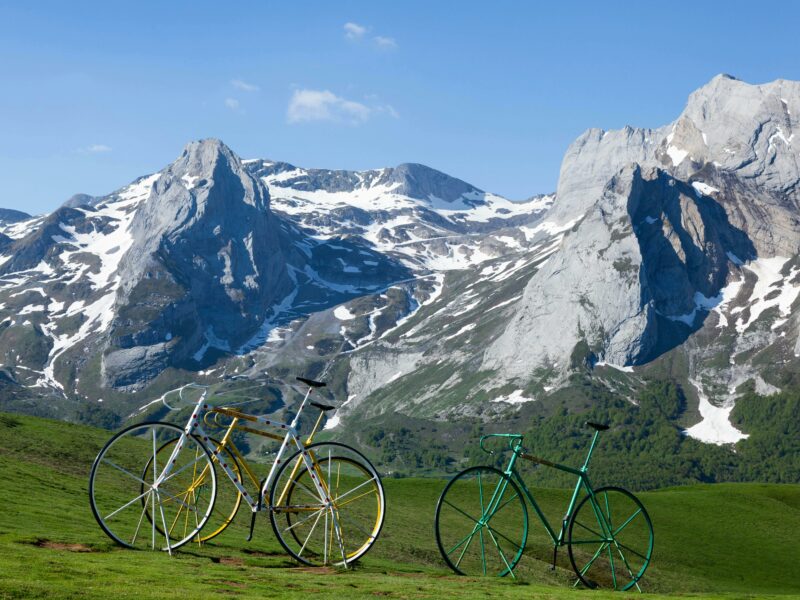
[103,140,294,386]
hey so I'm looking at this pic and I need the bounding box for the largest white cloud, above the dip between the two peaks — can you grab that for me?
[286,89,398,125]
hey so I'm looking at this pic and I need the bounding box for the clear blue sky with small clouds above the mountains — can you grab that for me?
[0,0,800,213]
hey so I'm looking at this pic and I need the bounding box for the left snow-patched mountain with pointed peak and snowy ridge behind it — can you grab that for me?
[0,140,552,416]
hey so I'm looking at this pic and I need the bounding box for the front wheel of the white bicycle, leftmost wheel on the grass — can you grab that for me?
[89,422,217,551]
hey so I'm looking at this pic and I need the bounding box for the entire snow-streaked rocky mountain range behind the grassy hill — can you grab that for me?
[0,75,800,485]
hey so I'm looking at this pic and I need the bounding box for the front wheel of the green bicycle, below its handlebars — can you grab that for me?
[434,467,528,577]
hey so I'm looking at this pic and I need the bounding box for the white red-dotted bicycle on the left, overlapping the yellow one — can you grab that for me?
[89,377,385,567]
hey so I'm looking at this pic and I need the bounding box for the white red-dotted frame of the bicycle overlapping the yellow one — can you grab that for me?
[155,384,347,567]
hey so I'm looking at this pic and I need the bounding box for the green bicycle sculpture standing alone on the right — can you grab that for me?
[435,423,653,591]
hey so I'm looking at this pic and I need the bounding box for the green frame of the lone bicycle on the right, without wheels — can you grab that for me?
[480,431,610,552]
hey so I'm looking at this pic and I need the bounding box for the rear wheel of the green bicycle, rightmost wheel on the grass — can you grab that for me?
[567,487,653,590]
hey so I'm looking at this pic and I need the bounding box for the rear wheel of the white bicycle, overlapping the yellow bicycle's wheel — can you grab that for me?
[270,442,386,566]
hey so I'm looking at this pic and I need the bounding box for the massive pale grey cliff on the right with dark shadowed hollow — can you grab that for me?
[484,75,800,379]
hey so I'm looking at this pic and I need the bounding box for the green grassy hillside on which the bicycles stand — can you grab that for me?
[0,413,800,598]
